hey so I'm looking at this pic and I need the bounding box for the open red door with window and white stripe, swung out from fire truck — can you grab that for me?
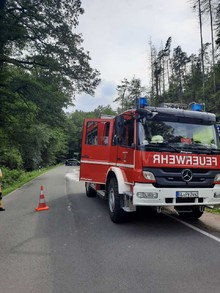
[80,118,113,184]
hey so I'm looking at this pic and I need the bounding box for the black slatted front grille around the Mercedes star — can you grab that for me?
[143,168,220,188]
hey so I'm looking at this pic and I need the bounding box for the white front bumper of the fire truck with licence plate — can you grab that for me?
[133,183,220,206]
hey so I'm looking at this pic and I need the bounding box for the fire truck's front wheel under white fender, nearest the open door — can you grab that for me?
[108,178,125,223]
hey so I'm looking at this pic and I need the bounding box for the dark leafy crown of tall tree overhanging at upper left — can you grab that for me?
[0,0,99,94]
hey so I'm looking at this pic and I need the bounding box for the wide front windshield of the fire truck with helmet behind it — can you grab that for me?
[138,115,219,150]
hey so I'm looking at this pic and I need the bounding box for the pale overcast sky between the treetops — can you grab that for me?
[71,0,210,112]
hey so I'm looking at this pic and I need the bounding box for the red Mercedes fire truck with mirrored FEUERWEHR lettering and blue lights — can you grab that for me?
[80,98,220,223]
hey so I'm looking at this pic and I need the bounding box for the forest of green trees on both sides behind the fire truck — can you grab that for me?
[0,0,220,171]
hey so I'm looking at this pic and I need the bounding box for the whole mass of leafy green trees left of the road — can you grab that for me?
[0,0,99,170]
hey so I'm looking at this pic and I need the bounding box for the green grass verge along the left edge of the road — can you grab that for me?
[2,166,56,197]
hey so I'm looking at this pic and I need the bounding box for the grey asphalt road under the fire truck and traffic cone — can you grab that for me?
[0,166,220,293]
